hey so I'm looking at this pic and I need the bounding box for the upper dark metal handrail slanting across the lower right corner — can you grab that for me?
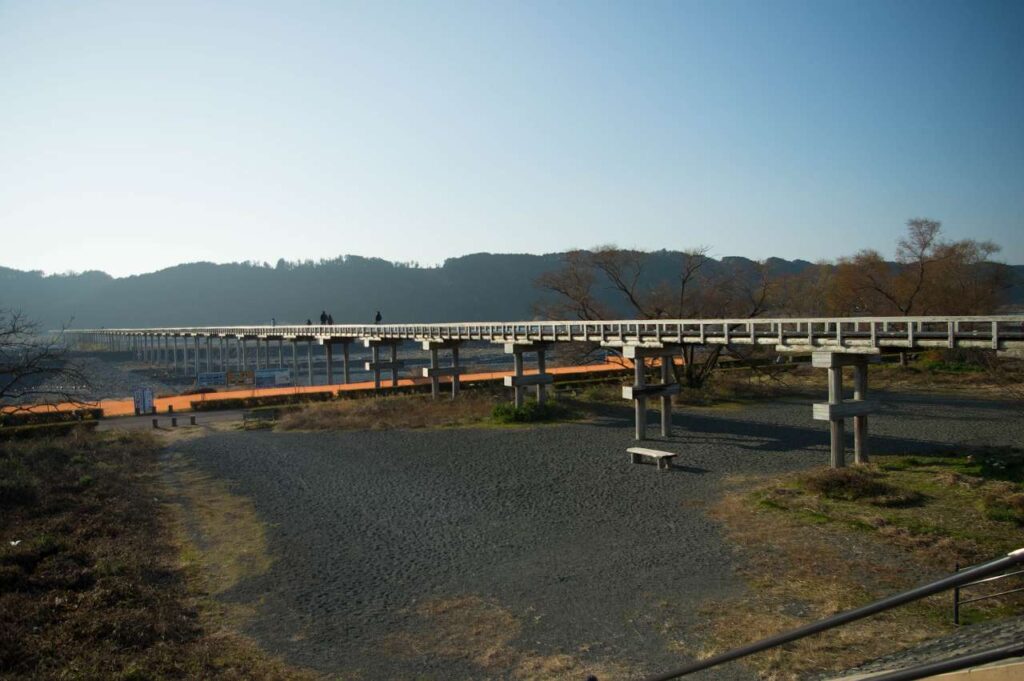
[645,548,1024,681]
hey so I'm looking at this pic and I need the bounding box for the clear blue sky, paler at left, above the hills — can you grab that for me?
[0,0,1024,274]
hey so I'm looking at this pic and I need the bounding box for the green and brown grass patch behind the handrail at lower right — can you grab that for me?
[701,450,1024,679]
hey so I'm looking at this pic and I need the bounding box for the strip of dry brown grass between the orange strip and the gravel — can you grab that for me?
[276,391,498,430]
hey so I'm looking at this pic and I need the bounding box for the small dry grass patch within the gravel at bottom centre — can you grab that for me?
[387,596,628,681]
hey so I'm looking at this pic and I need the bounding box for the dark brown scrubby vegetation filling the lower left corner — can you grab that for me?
[0,433,314,679]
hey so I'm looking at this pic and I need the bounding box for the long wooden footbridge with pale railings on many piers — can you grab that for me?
[66,314,1024,466]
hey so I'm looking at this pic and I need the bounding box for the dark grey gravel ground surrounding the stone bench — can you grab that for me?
[163,394,1024,679]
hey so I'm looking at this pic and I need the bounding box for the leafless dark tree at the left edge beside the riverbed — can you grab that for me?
[0,309,88,412]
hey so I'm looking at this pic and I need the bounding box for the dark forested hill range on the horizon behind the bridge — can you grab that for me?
[0,251,1024,328]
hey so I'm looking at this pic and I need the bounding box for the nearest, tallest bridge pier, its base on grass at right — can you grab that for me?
[811,352,879,468]
